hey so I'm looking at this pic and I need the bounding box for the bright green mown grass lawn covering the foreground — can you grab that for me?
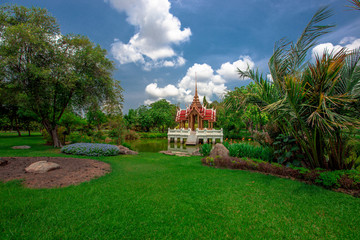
[0,135,360,239]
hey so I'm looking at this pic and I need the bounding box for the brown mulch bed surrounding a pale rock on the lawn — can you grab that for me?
[0,157,111,188]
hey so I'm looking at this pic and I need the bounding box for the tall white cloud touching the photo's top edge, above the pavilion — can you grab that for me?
[105,0,191,70]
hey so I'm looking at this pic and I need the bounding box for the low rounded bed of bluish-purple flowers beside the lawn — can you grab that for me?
[61,143,119,156]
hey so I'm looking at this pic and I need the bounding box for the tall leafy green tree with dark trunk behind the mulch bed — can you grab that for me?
[0,5,122,147]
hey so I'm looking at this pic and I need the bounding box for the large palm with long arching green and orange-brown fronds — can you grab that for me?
[238,8,360,170]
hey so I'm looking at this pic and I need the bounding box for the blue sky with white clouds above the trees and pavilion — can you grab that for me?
[2,0,360,113]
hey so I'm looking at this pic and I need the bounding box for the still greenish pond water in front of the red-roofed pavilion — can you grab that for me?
[125,138,198,153]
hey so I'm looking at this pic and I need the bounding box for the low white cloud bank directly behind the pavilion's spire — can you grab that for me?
[144,56,255,104]
